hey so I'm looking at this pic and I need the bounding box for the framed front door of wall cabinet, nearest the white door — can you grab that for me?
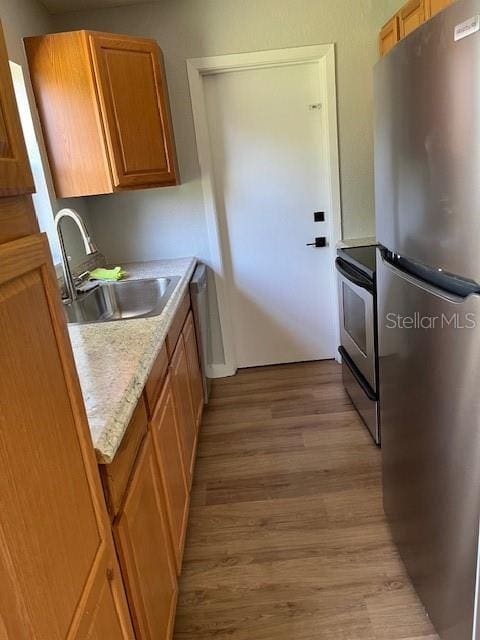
[90,33,177,189]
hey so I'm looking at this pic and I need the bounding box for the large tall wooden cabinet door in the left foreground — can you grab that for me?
[0,234,133,640]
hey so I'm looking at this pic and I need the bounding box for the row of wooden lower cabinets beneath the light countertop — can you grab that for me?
[100,298,204,640]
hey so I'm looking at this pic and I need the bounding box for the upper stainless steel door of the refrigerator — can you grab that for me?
[374,0,480,282]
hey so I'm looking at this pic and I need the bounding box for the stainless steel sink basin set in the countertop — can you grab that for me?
[64,276,180,324]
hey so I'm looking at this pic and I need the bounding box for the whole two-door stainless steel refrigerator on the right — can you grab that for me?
[374,0,480,640]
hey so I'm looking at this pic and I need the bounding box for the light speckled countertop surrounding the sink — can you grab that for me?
[68,258,196,463]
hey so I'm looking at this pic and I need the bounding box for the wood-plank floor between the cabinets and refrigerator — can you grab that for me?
[175,361,438,640]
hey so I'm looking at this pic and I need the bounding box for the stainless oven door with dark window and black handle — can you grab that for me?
[335,258,377,392]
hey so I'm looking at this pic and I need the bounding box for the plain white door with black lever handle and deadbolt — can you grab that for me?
[204,63,336,367]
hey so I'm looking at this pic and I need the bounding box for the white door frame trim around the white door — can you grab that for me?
[187,44,342,378]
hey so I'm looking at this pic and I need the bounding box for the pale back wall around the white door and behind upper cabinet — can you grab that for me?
[54,0,402,261]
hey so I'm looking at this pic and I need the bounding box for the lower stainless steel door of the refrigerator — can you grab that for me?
[377,252,480,640]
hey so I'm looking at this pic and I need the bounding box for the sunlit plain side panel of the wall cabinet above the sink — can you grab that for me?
[24,31,113,198]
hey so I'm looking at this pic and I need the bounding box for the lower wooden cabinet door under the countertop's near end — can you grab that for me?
[114,435,177,640]
